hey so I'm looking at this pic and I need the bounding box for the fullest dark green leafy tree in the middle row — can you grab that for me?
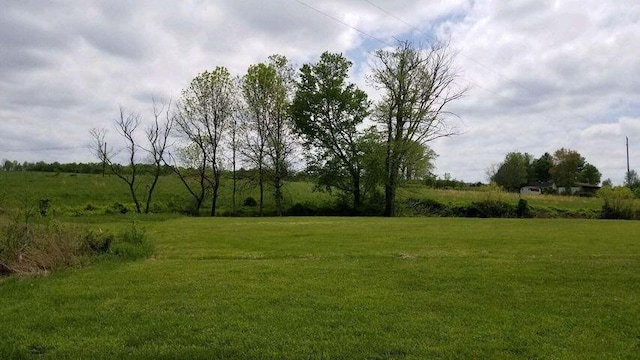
[291,52,370,211]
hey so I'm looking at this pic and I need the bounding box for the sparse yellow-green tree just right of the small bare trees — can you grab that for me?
[176,66,235,216]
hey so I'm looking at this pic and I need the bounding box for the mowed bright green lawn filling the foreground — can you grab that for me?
[0,218,640,359]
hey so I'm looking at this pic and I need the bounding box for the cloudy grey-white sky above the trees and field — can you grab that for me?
[0,0,640,184]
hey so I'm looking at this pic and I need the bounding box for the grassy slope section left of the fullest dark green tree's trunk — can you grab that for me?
[0,171,331,215]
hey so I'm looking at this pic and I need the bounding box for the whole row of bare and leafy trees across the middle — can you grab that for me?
[86,42,466,216]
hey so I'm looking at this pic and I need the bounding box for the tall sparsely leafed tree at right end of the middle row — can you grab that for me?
[370,41,465,216]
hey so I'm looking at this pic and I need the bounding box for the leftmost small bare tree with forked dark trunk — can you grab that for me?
[90,106,142,213]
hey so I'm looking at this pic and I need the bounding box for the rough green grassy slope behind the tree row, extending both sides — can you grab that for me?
[0,171,616,215]
